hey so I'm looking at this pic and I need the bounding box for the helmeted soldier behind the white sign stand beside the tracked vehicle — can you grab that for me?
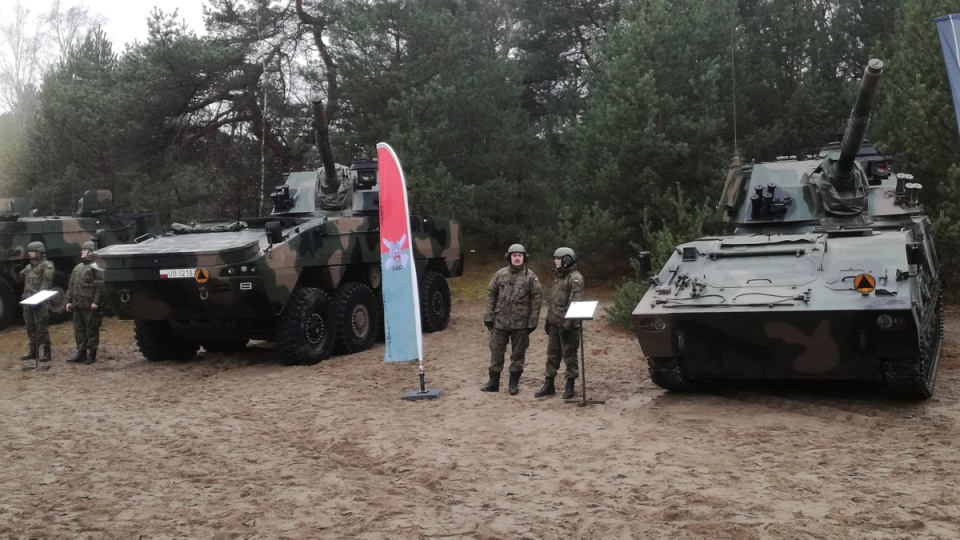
[533,247,583,399]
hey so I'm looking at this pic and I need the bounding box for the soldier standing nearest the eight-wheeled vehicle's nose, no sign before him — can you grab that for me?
[64,242,103,364]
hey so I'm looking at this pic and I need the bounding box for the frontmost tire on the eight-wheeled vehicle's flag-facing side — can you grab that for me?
[276,287,337,365]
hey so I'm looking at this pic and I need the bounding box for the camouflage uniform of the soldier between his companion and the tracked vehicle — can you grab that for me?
[546,265,584,380]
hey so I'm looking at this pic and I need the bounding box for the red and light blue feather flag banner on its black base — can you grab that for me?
[377,143,443,401]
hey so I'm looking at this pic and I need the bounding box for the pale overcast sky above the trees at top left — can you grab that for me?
[0,0,204,52]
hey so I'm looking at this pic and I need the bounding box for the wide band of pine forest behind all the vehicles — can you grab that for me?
[0,0,960,292]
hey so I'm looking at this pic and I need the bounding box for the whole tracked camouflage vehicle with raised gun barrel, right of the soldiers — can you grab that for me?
[633,60,943,399]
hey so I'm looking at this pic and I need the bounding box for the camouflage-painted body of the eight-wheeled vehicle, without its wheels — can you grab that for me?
[95,167,464,341]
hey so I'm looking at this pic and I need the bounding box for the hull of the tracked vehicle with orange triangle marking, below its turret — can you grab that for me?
[633,223,943,398]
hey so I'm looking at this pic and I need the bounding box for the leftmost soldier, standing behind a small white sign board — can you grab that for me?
[20,242,55,370]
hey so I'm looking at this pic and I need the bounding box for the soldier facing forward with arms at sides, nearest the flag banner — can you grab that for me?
[480,244,542,396]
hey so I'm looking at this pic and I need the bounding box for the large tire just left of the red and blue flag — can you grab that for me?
[333,281,382,354]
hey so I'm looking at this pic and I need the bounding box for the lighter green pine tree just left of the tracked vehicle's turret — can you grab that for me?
[566,1,734,262]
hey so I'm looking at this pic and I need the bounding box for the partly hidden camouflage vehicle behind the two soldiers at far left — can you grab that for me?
[0,190,161,328]
